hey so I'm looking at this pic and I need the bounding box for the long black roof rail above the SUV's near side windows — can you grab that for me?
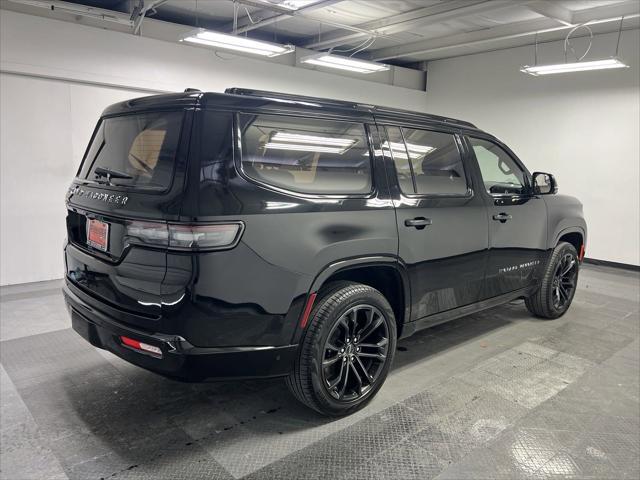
[224,87,477,128]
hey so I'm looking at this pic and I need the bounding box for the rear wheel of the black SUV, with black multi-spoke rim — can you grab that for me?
[287,282,396,417]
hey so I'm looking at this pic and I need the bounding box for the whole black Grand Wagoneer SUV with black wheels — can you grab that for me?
[64,89,586,415]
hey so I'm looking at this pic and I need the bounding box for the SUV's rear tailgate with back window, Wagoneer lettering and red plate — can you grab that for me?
[65,106,191,331]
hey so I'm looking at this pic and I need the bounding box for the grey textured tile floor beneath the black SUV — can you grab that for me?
[0,266,640,480]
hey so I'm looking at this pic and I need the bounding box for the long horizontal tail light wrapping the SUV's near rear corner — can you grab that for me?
[126,221,244,251]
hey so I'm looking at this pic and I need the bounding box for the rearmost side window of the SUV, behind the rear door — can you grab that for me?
[240,115,371,194]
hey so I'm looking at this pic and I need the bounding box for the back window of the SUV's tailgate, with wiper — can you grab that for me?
[78,112,184,190]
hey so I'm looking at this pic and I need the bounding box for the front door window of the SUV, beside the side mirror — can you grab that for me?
[469,137,527,194]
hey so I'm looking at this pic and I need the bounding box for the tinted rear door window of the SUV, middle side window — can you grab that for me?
[388,127,468,195]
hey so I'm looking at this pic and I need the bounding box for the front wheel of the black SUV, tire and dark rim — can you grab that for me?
[525,242,580,319]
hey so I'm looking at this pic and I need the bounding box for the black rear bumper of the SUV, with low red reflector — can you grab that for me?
[63,280,298,381]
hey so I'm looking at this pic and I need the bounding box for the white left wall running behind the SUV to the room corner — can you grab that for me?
[0,10,426,285]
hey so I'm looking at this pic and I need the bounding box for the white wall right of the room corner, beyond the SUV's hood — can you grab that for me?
[427,30,640,265]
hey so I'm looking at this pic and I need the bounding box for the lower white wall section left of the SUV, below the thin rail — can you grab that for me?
[0,74,146,285]
